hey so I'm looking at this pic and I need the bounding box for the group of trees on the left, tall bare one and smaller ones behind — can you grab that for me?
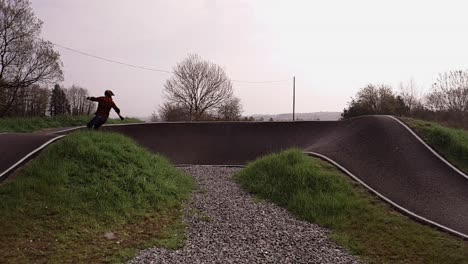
[0,0,95,117]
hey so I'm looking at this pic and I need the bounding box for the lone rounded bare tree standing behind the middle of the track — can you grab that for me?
[164,55,233,120]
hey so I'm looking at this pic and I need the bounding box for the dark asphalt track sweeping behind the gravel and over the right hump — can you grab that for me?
[0,116,468,234]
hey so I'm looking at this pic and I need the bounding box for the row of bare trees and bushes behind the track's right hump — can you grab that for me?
[341,70,468,128]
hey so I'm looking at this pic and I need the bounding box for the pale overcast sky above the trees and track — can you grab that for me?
[32,0,468,116]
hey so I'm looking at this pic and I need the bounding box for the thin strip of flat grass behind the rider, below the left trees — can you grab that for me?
[0,115,142,132]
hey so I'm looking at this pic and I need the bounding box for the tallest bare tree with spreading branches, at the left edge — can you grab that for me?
[0,0,63,117]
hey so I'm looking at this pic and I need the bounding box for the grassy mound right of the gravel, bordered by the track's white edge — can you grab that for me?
[236,150,468,263]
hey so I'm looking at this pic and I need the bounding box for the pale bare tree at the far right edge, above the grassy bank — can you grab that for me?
[427,71,468,113]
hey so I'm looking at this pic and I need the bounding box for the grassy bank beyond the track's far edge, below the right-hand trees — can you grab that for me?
[403,118,468,173]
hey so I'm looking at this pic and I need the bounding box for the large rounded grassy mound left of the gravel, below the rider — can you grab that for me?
[0,131,193,263]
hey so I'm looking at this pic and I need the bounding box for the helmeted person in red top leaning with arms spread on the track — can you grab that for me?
[86,90,124,129]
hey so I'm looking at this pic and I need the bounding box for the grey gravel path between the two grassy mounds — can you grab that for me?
[129,166,358,264]
